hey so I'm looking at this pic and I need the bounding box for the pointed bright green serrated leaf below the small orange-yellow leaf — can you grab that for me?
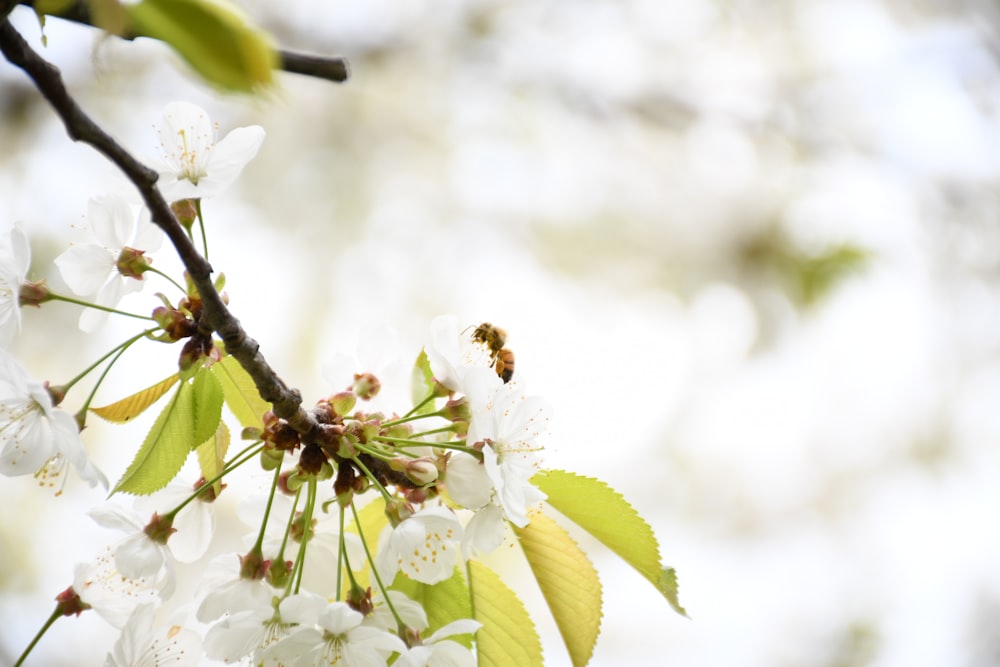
[111,382,197,496]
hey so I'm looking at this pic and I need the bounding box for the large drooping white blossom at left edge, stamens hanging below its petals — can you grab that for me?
[0,349,108,495]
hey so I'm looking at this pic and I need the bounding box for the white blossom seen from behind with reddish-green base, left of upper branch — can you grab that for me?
[55,195,163,331]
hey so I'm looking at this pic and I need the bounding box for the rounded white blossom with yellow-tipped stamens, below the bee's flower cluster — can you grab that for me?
[375,506,462,584]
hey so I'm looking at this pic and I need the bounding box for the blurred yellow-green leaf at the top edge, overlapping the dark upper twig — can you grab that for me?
[125,0,277,92]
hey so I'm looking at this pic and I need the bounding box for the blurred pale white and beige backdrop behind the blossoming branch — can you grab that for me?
[0,0,1000,667]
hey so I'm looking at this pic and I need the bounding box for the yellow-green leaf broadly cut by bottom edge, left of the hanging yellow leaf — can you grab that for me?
[468,560,544,667]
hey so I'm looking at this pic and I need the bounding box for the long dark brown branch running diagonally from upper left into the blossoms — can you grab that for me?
[0,19,319,442]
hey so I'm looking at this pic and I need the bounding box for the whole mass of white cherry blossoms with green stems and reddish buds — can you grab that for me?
[0,103,549,667]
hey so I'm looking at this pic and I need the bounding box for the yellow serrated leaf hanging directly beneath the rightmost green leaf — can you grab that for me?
[515,514,601,667]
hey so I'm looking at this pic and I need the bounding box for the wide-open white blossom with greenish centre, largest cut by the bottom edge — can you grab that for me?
[270,594,406,667]
